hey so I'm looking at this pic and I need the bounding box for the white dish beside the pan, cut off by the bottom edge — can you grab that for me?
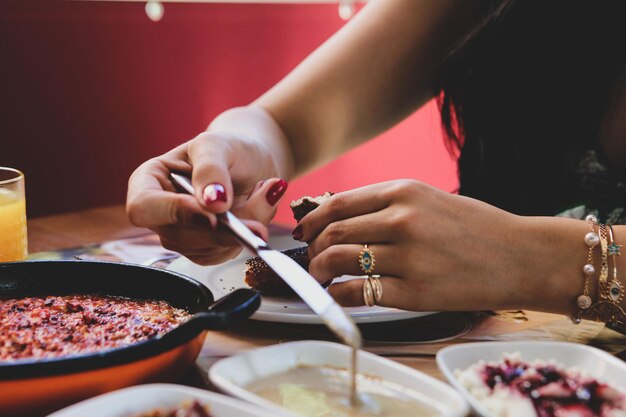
[48,384,288,417]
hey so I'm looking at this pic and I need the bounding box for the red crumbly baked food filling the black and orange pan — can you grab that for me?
[0,295,191,361]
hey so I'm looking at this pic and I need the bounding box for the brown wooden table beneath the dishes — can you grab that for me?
[28,206,626,388]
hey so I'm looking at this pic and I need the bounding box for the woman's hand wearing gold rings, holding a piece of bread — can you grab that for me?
[294,180,532,311]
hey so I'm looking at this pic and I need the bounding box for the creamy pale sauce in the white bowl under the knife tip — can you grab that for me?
[246,365,438,417]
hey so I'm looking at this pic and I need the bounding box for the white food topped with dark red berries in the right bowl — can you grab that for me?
[456,353,626,417]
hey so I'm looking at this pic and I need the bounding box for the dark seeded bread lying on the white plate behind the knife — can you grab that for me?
[244,246,309,295]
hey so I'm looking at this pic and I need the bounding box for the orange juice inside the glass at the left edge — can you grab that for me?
[0,187,28,262]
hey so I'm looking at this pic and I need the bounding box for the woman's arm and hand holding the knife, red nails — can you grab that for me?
[126,0,482,263]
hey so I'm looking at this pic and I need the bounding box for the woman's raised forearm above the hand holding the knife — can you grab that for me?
[209,0,481,177]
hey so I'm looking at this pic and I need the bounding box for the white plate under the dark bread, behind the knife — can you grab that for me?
[167,228,433,324]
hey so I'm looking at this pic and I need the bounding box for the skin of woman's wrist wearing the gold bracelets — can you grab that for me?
[512,217,626,321]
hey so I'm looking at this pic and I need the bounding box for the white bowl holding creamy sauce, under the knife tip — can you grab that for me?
[209,341,469,417]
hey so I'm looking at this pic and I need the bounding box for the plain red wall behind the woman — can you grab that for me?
[0,0,456,221]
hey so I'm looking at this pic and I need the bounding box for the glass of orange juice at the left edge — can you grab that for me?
[0,167,28,262]
